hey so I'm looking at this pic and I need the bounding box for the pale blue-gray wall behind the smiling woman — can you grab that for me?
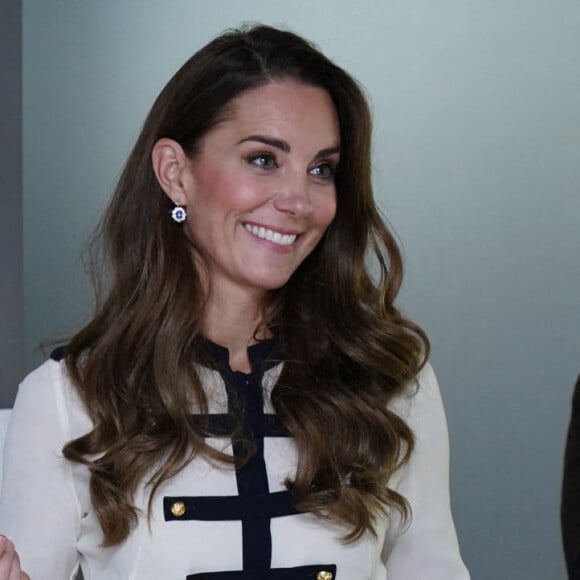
[14,0,580,580]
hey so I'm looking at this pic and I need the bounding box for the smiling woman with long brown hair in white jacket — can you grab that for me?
[0,26,468,580]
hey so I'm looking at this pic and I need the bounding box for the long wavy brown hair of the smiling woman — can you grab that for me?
[64,26,429,545]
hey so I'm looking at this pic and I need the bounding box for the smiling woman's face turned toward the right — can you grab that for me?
[179,80,340,294]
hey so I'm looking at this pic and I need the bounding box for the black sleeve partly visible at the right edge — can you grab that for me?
[560,377,580,578]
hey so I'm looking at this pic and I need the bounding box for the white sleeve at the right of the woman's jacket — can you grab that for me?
[383,365,469,580]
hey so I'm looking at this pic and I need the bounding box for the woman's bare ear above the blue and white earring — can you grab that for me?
[151,137,189,205]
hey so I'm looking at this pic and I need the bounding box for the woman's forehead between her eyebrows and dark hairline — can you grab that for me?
[208,80,340,148]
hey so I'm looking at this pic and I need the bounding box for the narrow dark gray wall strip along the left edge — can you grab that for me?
[0,0,23,408]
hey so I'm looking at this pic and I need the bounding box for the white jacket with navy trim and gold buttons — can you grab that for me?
[0,342,469,580]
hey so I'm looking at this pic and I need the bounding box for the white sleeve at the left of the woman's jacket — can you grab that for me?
[0,361,80,580]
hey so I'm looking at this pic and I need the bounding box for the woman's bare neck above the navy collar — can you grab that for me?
[202,289,267,373]
